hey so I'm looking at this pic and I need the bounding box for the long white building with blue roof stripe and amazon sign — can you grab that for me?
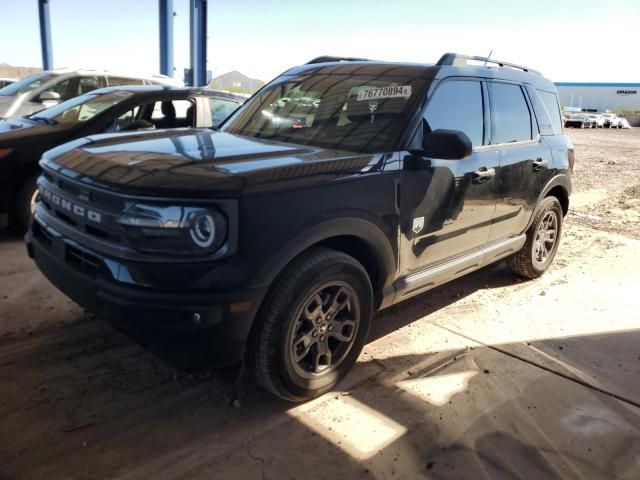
[556,82,640,111]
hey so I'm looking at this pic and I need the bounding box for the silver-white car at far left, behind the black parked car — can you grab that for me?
[0,69,175,119]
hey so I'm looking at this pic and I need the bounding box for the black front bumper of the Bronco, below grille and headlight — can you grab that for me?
[25,219,266,370]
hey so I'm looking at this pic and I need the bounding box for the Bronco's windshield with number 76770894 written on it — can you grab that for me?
[223,73,426,153]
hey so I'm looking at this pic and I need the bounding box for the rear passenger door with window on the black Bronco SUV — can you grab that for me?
[488,81,551,244]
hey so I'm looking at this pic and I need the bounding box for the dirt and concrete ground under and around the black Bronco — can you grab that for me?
[0,129,640,479]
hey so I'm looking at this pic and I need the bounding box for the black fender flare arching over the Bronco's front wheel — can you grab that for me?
[250,217,397,289]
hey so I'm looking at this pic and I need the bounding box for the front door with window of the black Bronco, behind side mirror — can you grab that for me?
[400,79,499,276]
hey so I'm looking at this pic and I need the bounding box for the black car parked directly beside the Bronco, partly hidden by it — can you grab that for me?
[0,86,245,228]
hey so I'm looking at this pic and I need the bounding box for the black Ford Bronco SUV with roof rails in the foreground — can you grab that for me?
[27,54,573,401]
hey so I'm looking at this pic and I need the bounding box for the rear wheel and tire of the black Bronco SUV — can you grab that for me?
[506,196,563,278]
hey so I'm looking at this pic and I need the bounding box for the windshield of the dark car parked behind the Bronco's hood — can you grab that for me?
[29,91,133,125]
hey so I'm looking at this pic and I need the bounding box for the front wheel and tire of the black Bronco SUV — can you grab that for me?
[247,247,373,402]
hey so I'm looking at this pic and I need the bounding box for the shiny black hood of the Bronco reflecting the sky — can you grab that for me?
[41,129,383,196]
